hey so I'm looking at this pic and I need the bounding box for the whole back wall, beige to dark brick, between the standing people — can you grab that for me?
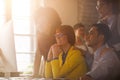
[45,0,98,26]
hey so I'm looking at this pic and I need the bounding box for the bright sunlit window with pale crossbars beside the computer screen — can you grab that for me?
[12,0,36,71]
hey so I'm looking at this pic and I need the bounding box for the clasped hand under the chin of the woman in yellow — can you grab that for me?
[51,44,62,59]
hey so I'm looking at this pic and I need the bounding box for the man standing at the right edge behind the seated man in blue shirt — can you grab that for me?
[96,0,120,54]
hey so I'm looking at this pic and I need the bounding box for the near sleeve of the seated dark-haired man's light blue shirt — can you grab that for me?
[87,52,114,79]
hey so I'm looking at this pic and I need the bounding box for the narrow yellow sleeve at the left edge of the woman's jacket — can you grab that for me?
[45,61,53,78]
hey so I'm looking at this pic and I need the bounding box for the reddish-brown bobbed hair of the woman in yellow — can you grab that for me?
[56,25,75,45]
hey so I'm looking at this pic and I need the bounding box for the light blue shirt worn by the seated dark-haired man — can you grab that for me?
[87,45,120,80]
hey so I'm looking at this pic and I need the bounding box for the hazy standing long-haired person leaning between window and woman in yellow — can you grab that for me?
[33,7,61,77]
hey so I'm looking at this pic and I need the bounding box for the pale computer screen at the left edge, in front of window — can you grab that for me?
[0,21,17,72]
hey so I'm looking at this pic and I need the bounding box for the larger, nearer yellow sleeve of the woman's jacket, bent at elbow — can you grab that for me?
[51,50,86,78]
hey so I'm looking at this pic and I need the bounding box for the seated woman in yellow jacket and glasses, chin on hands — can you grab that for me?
[45,25,87,80]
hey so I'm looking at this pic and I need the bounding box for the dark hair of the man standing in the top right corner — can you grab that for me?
[101,0,120,14]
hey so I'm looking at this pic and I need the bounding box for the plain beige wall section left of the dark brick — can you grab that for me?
[45,0,78,25]
